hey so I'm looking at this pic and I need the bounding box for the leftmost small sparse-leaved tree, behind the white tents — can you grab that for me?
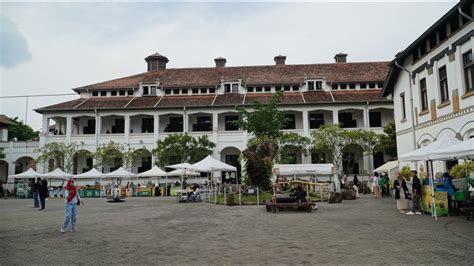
[36,142,84,173]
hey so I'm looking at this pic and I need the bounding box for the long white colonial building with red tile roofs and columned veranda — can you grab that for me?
[27,53,393,177]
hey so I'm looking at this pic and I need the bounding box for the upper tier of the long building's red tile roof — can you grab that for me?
[74,62,389,91]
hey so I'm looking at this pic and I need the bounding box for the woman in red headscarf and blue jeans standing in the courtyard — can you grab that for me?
[61,179,81,233]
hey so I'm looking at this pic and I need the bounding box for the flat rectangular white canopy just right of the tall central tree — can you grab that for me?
[273,163,334,176]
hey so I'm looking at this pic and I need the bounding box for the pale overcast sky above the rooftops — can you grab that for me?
[0,1,456,130]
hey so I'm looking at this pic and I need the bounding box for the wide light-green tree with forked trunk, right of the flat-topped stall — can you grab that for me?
[311,125,379,175]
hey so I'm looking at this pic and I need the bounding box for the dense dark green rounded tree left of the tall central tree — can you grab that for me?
[152,134,216,166]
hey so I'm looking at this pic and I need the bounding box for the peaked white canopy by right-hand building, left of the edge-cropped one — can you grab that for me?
[398,135,461,162]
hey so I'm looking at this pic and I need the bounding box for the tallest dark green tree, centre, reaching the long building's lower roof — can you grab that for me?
[236,91,286,189]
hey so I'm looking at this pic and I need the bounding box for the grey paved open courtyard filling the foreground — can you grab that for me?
[0,196,474,265]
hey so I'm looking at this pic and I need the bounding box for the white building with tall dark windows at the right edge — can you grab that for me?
[383,1,474,172]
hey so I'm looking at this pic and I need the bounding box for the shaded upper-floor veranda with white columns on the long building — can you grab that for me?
[42,107,393,141]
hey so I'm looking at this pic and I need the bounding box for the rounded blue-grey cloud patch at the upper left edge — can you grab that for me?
[0,15,31,68]
